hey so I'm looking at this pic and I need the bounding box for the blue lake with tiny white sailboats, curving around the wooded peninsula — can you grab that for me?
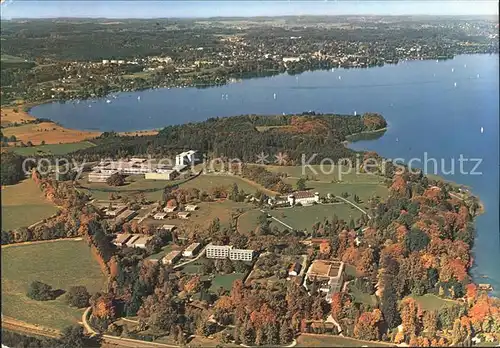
[32,55,500,295]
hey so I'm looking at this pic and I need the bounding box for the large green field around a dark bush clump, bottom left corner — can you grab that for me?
[2,240,106,329]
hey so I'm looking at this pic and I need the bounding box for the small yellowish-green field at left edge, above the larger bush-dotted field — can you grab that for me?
[2,179,58,231]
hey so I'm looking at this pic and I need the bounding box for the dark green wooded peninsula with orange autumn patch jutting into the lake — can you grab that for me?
[72,113,386,165]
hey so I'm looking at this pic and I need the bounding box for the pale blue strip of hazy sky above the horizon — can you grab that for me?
[2,0,498,19]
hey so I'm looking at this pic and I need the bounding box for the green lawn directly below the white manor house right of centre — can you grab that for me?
[268,204,361,232]
